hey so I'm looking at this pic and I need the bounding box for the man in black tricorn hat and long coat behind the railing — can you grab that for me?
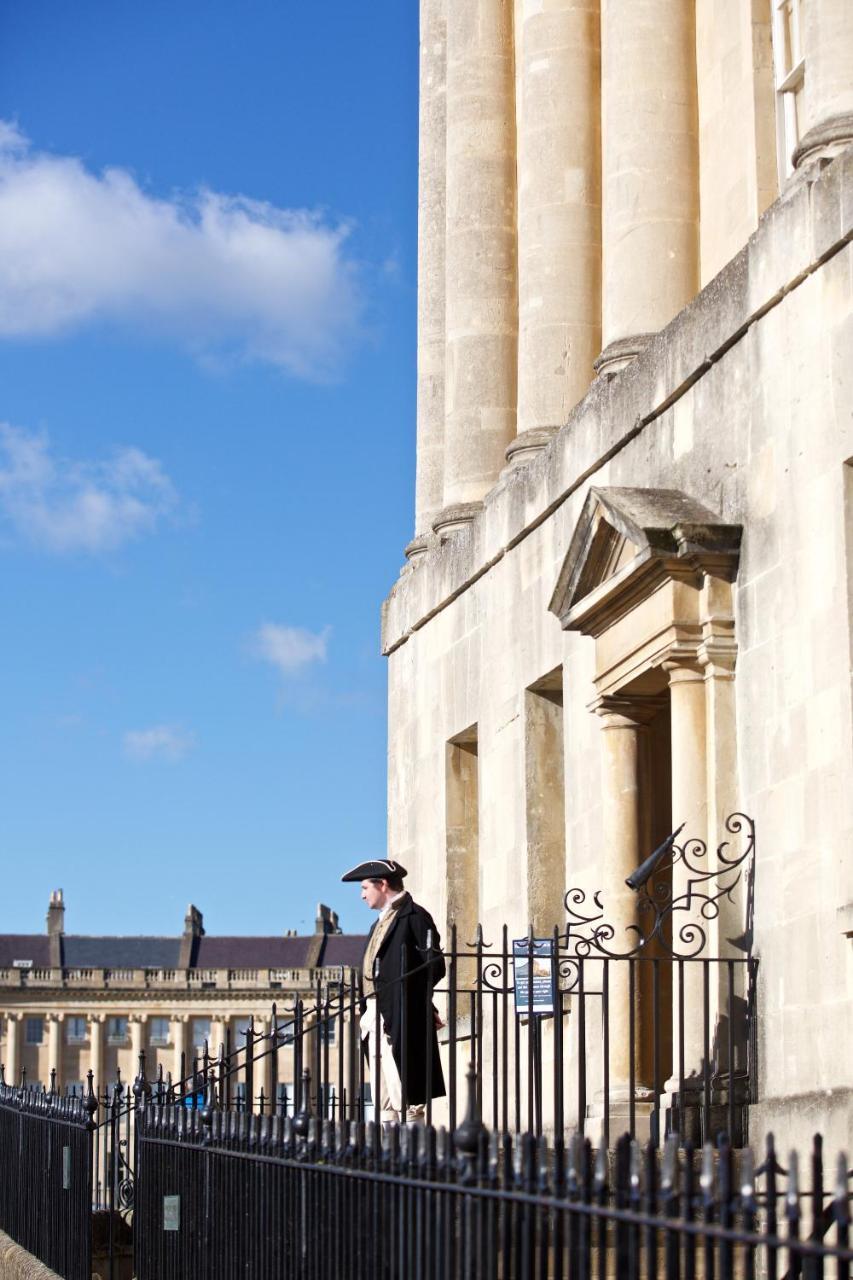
[341,859,444,1124]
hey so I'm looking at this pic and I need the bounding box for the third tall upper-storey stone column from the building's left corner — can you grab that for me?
[507,0,601,461]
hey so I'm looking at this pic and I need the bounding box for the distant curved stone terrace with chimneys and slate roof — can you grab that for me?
[0,890,366,1101]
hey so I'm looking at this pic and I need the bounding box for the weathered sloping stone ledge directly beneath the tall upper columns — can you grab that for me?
[382,147,853,655]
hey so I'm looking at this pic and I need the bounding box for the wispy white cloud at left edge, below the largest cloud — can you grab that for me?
[0,422,178,552]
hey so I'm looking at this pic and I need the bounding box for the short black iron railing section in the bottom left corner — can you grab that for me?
[0,1084,92,1280]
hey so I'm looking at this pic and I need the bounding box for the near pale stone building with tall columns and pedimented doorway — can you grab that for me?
[383,0,853,1146]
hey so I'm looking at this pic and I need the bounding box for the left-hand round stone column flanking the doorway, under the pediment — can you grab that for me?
[596,695,647,1107]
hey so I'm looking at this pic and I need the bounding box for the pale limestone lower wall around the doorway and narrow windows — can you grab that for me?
[383,151,853,1146]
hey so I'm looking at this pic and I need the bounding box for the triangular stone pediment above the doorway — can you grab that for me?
[549,488,740,628]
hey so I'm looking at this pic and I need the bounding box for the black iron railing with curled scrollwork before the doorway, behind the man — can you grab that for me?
[128,814,758,1146]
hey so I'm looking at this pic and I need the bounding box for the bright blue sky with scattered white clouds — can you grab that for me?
[0,0,418,933]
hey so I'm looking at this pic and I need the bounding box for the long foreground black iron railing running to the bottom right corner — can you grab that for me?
[134,1073,853,1280]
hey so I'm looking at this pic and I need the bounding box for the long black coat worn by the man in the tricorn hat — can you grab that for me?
[370,900,444,1106]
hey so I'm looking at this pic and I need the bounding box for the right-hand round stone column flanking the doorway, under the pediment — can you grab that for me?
[663,655,713,1092]
